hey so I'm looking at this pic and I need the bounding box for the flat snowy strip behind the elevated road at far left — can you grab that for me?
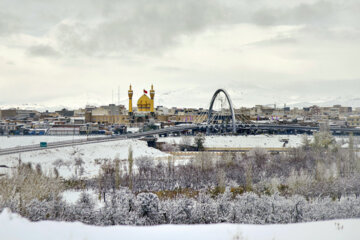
[0,135,105,149]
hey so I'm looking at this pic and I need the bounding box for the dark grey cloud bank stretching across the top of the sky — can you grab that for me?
[0,0,360,57]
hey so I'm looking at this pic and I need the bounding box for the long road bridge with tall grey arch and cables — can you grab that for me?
[0,89,360,155]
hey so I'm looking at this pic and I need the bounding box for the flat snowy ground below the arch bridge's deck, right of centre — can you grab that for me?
[158,135,359,148]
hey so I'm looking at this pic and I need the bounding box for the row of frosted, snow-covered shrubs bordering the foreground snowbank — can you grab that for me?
[1,188,360,225]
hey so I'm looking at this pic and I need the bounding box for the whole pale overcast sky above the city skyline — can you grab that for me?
[0,0,360,107]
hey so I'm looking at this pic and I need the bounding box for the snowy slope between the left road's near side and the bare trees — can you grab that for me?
[0,138,168,178]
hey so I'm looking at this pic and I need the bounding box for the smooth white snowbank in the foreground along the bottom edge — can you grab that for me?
[0,209,360,240]
